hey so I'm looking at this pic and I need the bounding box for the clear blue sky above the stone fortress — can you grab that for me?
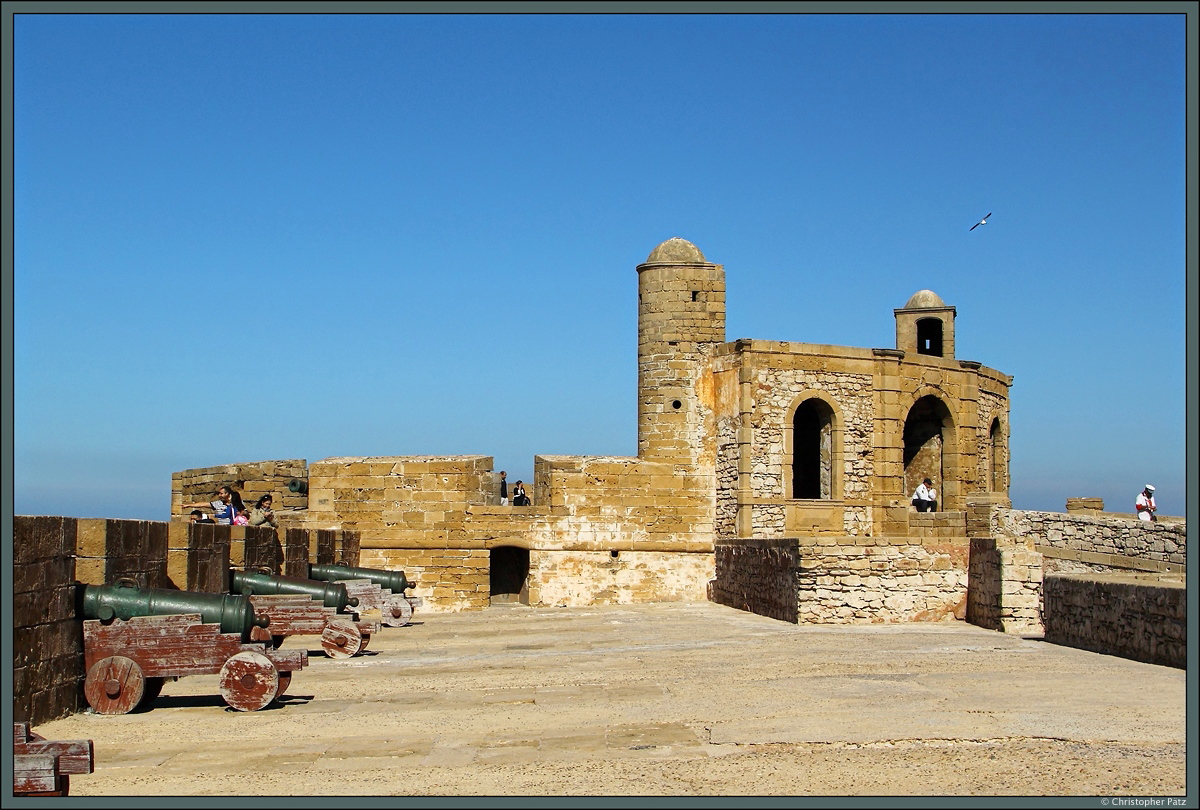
[11,14,1194,520]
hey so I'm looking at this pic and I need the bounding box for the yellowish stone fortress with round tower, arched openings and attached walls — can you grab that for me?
[159,239,1182,652]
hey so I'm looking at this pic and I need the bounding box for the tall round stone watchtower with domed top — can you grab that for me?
[637,236,725,460]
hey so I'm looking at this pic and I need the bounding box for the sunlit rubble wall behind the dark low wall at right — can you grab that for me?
[991,509,1187,571]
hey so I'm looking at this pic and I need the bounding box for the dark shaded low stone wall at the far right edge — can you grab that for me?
[1043,575,1187,668]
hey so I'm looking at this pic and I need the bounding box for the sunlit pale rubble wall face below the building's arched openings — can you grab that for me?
[797,536,970,624]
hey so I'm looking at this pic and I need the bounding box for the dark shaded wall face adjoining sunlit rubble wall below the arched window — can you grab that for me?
[708,539,800,623]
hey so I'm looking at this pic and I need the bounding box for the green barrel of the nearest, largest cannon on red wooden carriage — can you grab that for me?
[82,582,270,642]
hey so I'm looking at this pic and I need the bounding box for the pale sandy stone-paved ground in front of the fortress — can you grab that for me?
[37,604,1195,806]
